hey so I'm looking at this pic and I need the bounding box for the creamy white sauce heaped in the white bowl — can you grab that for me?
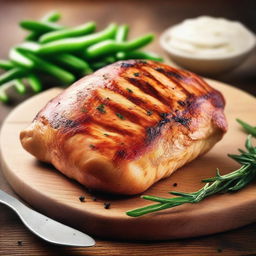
[165,16,255,58]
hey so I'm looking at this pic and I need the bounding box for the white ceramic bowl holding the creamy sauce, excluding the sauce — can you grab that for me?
[160,27,256,75]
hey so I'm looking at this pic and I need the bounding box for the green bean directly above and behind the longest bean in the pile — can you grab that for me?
[39,22,96,43]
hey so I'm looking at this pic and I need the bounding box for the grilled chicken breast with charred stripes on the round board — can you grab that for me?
[20,60,227,195]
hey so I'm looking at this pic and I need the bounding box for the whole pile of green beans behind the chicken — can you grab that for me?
[0,12,162,102]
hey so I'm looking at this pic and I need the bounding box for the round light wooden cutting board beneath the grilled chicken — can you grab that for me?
[0,80,256,240]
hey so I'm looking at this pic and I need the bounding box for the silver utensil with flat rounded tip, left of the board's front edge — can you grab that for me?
[0,190,95,247]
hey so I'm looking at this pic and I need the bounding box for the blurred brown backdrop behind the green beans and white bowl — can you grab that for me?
[0,0,256,95]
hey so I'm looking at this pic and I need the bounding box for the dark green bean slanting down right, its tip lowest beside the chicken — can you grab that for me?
[23,52,75,84]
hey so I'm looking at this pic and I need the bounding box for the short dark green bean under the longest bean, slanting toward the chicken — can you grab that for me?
[53,53,92,74]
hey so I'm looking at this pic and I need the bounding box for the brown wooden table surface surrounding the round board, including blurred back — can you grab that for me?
[0,0,256,256]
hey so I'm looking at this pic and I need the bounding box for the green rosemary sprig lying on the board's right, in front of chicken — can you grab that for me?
[126,125,256,217]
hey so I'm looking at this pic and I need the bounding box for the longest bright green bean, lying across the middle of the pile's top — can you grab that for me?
[38,24,117,54]
